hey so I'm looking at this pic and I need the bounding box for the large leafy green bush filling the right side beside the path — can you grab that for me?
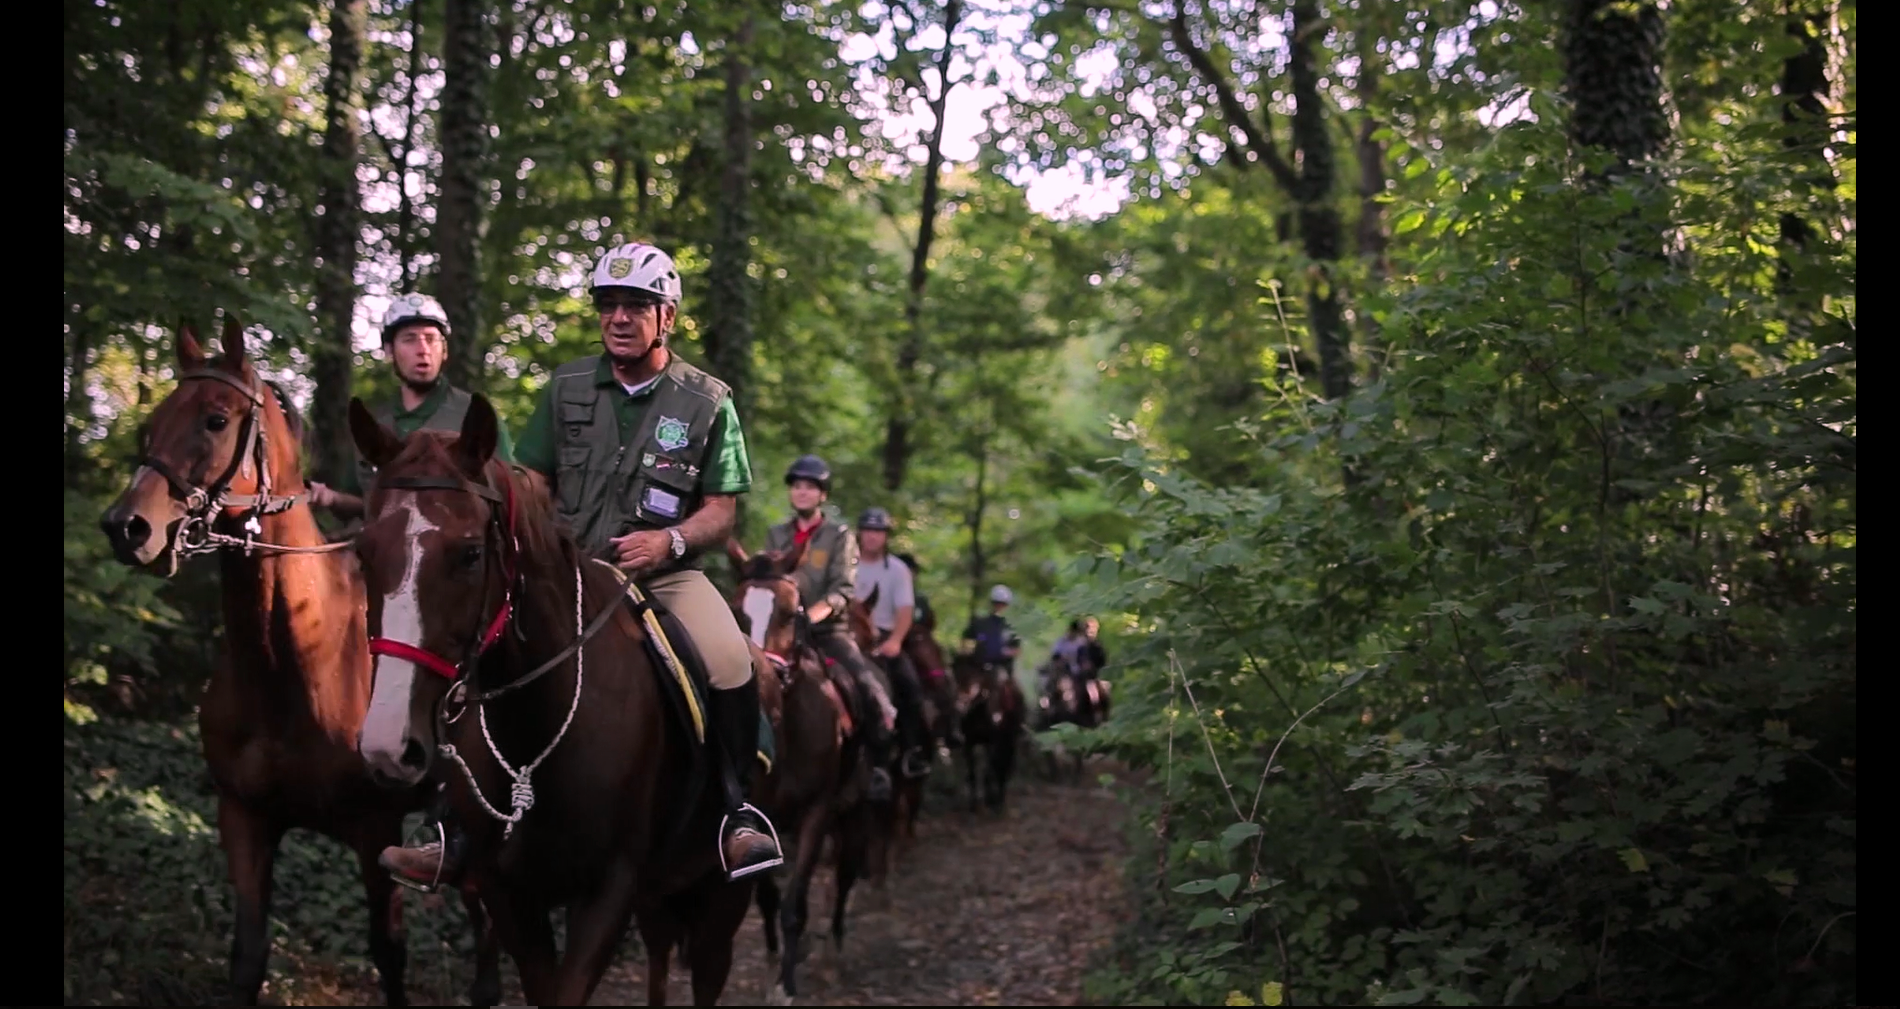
[1074,114,1858,1005]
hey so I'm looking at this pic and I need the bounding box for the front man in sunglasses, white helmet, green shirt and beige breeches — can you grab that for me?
[382,243,785,884]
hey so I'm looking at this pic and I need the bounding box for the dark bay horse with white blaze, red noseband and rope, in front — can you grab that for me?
[350,395,752,1005]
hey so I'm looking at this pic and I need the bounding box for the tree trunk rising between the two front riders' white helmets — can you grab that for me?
[435,0,488,388]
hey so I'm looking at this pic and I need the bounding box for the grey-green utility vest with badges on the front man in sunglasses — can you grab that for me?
[553,355,732,570]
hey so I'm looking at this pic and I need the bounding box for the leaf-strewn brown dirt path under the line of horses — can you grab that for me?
[593,771,1125,1005]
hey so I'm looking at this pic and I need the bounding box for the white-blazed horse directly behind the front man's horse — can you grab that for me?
[726,540,882,1005]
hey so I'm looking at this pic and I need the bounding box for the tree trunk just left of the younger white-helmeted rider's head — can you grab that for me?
[310,0,365,481]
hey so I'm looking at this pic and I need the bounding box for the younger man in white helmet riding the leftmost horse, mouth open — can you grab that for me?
[310,295,515,519]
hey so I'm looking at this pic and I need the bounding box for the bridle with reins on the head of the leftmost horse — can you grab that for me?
[139,369,350,574]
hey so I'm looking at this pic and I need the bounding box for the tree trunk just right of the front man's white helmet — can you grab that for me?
[707,13,756,416]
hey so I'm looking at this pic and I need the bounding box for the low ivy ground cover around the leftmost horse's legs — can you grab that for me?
[63,718,473,1005]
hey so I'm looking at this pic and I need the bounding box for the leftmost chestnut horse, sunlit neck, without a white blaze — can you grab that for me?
[101,315,502,1005]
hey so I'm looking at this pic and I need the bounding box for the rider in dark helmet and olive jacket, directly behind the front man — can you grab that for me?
[766,456,897,802]
